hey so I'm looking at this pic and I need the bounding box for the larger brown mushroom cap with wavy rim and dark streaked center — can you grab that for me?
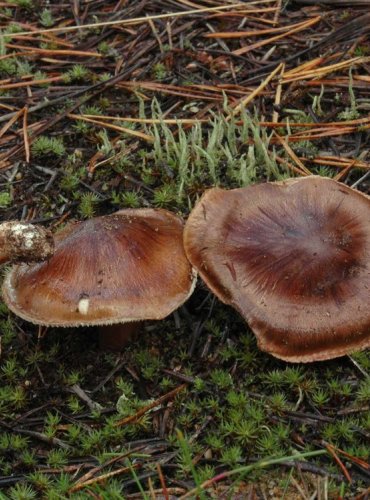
[184,176,370,362]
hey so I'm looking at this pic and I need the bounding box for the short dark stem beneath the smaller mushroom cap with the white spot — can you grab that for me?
[99,321,143,351]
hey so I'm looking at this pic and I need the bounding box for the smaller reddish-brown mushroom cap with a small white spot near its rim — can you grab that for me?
[3,209,195,327]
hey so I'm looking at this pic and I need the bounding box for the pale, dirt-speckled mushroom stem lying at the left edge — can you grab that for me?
[0,221,54,264]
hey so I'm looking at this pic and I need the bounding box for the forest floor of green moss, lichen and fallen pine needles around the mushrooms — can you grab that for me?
[0,0,370,500]
